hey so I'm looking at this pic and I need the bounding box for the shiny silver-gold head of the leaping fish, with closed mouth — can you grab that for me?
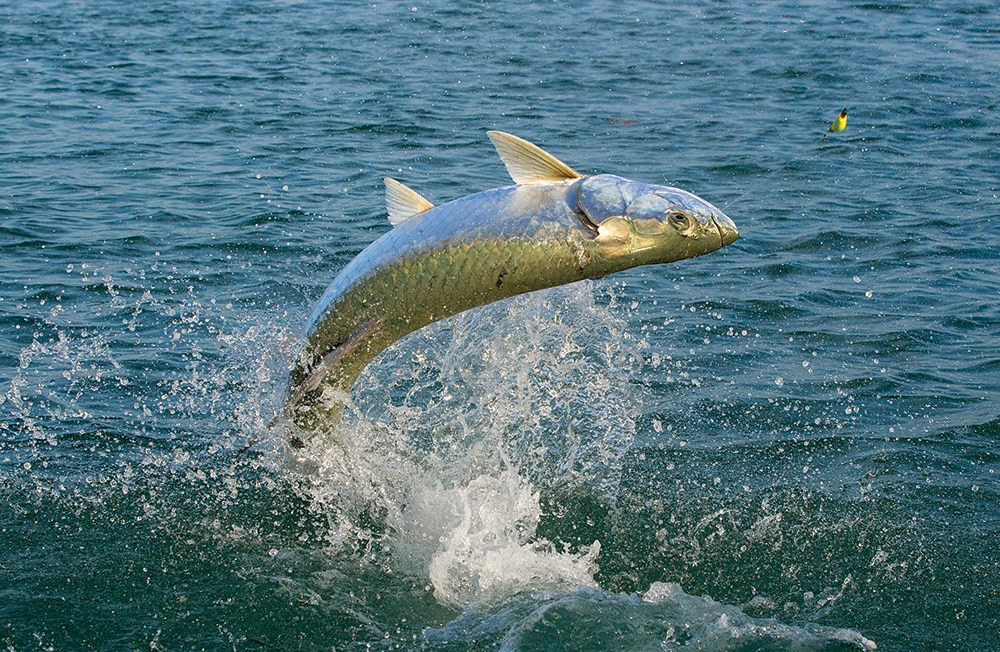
[567,174,740,269]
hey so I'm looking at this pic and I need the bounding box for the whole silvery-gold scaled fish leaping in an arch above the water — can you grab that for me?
[286,132,739,443]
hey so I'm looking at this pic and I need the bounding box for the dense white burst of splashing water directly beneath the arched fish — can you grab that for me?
[280,284,641,609]
